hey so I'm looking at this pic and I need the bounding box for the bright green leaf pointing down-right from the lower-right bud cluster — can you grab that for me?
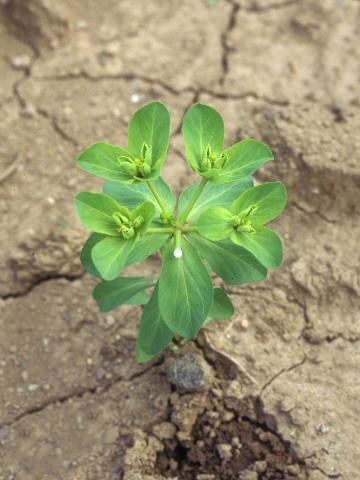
[230,226,283,268]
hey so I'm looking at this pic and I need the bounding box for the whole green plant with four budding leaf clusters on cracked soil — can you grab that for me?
[76,102,286,363]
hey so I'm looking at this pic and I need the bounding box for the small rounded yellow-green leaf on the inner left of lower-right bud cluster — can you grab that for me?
[197,207,234,240]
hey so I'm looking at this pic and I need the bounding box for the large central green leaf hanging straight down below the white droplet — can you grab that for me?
[159,240,213,339]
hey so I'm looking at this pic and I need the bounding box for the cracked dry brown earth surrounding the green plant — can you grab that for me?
[0,0,360,480]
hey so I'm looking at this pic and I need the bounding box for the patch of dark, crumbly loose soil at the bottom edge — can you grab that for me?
[157,394,305,480]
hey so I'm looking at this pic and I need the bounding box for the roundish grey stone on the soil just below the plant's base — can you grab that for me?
[166,353,213,392]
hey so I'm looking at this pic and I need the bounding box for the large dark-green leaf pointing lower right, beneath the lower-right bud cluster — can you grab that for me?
[189,234,267,285]
